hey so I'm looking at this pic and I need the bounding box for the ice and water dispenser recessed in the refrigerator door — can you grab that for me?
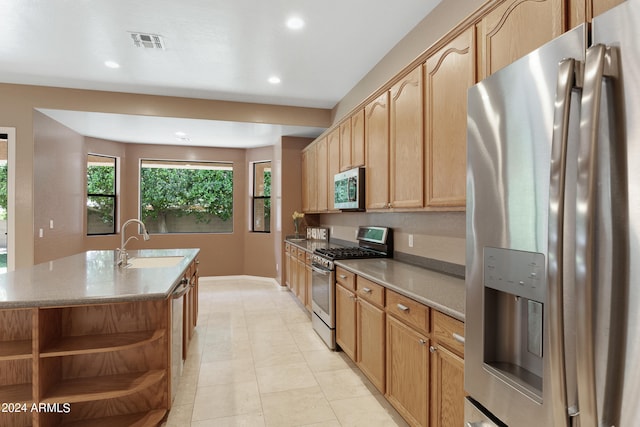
[484,247,546,401]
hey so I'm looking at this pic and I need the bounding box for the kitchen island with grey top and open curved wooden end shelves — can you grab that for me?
[0,249,199,426]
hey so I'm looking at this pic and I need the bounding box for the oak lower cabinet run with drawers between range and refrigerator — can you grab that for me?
[336,267,465,427]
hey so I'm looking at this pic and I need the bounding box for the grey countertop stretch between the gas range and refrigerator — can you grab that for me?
[336,258,465,322]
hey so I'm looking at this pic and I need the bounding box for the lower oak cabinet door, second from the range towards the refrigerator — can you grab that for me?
[356,299,386,393]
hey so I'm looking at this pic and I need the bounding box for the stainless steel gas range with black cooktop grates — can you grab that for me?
[311,226,393,350]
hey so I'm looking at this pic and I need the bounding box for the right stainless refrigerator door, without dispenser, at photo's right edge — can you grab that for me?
[576,0,640,427]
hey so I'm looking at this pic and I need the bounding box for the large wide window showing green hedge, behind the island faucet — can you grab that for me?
[140,160,233,234]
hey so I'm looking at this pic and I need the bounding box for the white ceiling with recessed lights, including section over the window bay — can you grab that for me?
[0,0,440,147]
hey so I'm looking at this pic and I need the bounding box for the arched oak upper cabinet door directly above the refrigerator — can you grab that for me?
[479,0,565,80]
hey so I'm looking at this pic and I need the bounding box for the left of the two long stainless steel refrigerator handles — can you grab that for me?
[547,58,579,427]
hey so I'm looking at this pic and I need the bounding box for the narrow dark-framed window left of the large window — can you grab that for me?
[87,154,116,235]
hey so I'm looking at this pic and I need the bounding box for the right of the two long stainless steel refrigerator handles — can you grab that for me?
[575,44,617,427]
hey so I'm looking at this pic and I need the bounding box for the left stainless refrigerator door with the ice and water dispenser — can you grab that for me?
[465,26,586,427]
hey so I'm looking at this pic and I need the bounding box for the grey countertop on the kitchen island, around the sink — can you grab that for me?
[0,249,200,309]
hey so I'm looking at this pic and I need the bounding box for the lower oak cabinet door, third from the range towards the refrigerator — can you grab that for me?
[386,316,430,426]
